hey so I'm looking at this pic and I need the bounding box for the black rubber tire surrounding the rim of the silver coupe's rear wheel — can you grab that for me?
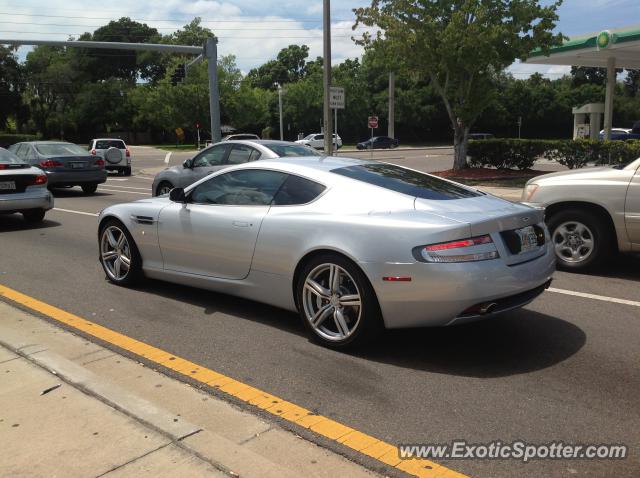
[295,253,384,349]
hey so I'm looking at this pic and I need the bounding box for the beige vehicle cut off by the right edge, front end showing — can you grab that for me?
[522,159,640,271]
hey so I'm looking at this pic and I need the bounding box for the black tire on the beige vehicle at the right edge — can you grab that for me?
[547,209,614,272]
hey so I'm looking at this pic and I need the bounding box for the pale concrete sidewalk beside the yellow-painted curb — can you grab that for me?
[0,302,377,478]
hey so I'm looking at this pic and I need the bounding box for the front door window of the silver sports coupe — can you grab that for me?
[190,169,287,206]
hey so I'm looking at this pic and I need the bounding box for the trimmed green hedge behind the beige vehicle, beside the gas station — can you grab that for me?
[468,139,640,170]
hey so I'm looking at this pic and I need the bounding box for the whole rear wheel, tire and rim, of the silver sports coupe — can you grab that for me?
[296,253,384,349]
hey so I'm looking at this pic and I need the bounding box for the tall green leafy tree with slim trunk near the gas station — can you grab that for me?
[354,0,563,169]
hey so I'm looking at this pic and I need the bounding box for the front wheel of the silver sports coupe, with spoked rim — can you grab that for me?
[98,219,142,286]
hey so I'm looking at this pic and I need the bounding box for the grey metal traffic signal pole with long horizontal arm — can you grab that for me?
[0,37,222,143]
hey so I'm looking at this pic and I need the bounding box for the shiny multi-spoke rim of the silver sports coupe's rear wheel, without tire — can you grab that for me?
[302,264,362,342]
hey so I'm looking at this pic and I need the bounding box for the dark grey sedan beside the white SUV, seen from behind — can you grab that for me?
[9,141,107,194]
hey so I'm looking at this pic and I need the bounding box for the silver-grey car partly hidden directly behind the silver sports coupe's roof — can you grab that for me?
[151,140,320,196]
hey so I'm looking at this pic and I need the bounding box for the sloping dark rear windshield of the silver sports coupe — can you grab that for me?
[331,163,480,200]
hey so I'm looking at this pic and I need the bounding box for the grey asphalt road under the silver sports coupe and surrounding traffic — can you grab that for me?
[0,148,640,477]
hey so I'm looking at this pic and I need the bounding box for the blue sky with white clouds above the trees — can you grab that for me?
[0,0,640,78]
